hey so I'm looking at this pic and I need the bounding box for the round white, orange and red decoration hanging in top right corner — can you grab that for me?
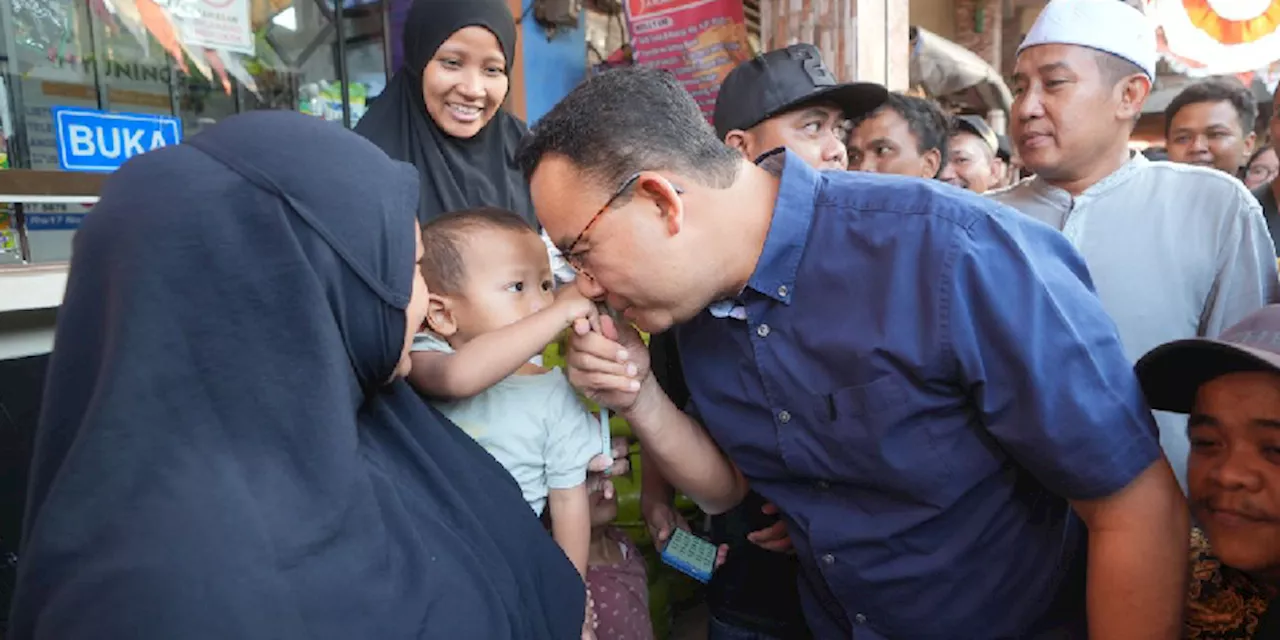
[1144,0,1280,84]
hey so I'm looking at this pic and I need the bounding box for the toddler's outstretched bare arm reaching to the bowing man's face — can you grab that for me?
[408,287,595,399]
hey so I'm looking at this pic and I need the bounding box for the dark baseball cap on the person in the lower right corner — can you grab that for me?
[1134,305,1280,413]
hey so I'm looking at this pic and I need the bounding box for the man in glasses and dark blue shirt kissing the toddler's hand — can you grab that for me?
[518,69,1188,640]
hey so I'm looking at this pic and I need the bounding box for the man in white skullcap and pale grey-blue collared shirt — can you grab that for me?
[991,0,1280,488]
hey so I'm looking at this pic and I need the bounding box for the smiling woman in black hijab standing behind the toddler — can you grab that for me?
[356,0,538,228]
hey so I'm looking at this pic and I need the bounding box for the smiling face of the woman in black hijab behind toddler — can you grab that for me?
[422,27,509,138]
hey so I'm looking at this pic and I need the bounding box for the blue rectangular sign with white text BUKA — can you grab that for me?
[51,106,182,173]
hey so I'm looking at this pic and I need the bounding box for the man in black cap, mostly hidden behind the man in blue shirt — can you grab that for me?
[640,45,888,640]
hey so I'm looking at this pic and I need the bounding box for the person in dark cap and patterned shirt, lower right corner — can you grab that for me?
[1137,305,1280,640]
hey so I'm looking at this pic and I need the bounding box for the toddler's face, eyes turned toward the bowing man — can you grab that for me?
[453,228,556,342]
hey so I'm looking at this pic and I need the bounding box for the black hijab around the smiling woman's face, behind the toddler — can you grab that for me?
[356,0,539,228]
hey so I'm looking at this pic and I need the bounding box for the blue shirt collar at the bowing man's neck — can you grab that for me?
[746,151,820,305]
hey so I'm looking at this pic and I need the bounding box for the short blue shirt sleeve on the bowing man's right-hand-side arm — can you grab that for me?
[943,210,1162,499]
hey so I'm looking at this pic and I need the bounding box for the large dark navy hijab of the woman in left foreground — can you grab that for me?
[9,111,585,640]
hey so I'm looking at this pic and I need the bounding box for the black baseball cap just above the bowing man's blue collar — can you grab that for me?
[712,44,888,138]
